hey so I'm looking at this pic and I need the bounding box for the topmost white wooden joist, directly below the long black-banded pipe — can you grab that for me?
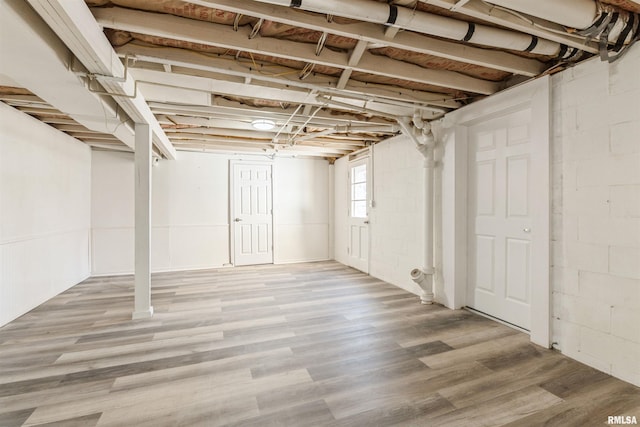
[191,0,544,77]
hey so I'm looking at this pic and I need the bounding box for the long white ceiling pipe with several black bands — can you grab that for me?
[250,0,560,55]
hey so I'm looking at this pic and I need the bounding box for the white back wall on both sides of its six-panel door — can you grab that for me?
[92,151,329,275]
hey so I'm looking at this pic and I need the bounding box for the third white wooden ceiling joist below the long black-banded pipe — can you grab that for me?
[116,43,461,109]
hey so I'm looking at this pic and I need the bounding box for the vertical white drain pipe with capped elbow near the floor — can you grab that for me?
[397,113,435,304]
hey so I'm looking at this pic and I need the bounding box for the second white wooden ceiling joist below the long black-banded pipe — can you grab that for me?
[92,7,501,95]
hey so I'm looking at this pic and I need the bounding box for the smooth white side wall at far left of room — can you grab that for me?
[0,103,91,325]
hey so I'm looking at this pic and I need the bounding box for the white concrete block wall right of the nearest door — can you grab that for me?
[551,45,640,385]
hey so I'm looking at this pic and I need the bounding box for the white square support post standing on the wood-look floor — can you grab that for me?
[133,123,153,319]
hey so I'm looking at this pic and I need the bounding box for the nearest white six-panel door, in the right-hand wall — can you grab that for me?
[467,109,548,330]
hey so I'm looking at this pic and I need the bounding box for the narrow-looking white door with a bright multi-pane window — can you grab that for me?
[349,158,369,273]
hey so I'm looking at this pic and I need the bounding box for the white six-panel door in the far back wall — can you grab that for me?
[230,162,273,265]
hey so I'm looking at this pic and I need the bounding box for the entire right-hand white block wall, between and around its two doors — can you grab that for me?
[334,44,640,385]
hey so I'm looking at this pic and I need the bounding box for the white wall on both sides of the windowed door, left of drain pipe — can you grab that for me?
[334,136,424,294]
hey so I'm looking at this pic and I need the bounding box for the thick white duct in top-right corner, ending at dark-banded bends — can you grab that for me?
[488,0,640,62]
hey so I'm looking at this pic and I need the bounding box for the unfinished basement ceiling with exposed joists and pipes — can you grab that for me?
[8,0,640,160]
